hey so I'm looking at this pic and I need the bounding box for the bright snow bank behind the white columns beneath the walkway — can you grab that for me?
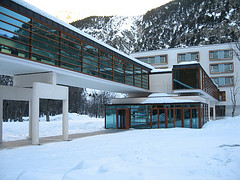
[3,113,104,141]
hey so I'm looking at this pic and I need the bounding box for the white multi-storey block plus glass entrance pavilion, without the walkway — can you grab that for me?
[105,43,240,129]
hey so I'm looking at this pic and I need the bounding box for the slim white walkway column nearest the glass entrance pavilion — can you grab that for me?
[62,99,68,141]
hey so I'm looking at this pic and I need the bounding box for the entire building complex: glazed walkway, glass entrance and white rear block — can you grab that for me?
[0,0,239,144]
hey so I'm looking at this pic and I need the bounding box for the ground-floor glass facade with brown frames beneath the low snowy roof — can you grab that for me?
[105,103,208,129]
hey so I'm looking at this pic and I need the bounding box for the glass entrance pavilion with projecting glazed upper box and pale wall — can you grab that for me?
[105,62,220,129]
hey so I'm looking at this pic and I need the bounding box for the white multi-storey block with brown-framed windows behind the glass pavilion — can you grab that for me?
[131,43,240,117]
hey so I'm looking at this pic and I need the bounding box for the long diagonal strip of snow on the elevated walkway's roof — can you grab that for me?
[13,0,154,69]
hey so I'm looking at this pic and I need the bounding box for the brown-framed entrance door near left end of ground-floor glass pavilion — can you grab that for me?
[117,109,130,129]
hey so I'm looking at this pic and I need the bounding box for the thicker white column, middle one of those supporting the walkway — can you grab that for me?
[31,83,39,145]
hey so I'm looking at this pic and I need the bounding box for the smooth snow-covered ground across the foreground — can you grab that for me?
[0,116,240,180]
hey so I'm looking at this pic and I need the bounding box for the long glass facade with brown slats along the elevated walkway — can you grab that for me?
[0,5,149,89]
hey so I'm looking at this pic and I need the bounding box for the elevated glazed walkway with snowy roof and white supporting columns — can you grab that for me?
[0,0,153,144]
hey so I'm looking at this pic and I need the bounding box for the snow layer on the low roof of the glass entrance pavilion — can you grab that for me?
[141,97,197,104]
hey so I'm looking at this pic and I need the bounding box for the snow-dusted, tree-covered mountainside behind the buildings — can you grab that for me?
[71,0,240,53]
